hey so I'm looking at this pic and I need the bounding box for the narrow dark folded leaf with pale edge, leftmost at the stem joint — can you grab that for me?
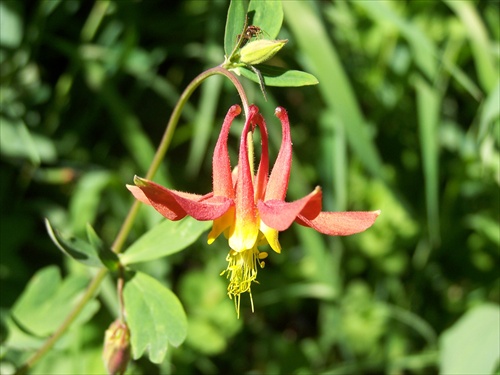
[45,219,103,267]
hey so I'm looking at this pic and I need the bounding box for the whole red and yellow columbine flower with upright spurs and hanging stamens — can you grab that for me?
[127,105,380,312]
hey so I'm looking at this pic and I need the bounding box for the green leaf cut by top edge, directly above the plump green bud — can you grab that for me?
[248,0,283,39]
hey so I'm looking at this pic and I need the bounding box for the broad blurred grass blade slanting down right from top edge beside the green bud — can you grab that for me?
[283,1,383,178]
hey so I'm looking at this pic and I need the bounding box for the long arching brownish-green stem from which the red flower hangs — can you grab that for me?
[16,66,248,375]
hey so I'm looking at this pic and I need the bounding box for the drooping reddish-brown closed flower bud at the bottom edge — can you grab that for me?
[102,319,130,375]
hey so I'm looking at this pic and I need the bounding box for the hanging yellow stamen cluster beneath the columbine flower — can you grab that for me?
[221,246,267,318]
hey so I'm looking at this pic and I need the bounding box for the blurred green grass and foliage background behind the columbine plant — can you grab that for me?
[0,0,500,374]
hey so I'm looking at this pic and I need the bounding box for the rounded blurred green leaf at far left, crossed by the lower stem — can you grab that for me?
[12,266,99,337]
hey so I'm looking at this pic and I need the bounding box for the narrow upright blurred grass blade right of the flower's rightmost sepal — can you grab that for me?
[415,77,441,245]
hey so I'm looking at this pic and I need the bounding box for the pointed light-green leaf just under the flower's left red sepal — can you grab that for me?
[121,217,212,264]
